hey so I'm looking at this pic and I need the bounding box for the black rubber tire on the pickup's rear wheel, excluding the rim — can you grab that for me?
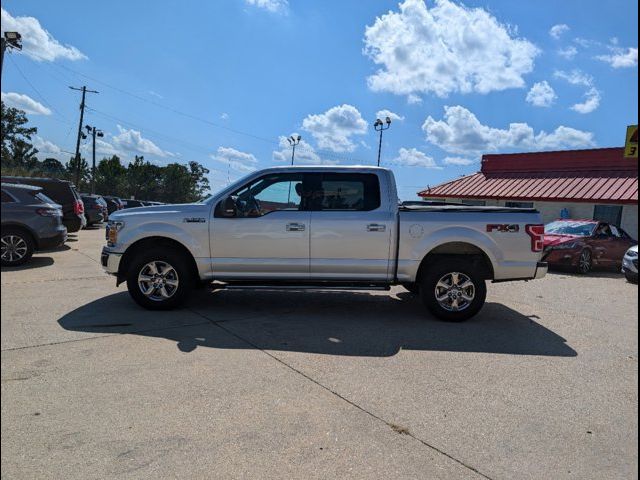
[420,257,487,322]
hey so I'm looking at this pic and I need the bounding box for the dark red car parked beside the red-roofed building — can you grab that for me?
[542,220,638,273]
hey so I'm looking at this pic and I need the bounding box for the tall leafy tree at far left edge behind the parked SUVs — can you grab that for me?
[0,102,38,169]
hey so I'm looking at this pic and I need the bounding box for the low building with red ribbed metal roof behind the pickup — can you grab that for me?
[418,148,638,238]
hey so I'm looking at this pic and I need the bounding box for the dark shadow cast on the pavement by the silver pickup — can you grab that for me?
[58,290,577,357]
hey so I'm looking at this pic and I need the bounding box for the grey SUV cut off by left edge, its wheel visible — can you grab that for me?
[0,183,67,266]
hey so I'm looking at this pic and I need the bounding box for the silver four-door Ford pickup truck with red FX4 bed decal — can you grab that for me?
[102,166,547,321]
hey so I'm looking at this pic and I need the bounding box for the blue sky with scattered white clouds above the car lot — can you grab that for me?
[2,0,638,199]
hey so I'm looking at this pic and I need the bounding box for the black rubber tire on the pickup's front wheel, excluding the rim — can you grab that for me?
[126,247,194,310]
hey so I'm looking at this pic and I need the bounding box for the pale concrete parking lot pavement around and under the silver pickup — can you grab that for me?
[2,229,638,479]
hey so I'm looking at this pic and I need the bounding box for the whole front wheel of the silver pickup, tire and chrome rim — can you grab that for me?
[127,249,193,310]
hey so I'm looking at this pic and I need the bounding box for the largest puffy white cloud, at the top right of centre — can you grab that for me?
[364,0,539,98]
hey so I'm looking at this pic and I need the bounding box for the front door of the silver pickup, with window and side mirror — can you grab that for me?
[211,173,311,280]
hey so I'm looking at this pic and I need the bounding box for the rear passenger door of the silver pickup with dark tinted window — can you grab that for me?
[305,172,395,281]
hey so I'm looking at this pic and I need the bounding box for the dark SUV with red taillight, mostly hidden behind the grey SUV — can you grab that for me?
[2,176,86,233]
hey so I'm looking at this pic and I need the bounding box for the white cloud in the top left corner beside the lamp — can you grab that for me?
[1,8,87,62]
